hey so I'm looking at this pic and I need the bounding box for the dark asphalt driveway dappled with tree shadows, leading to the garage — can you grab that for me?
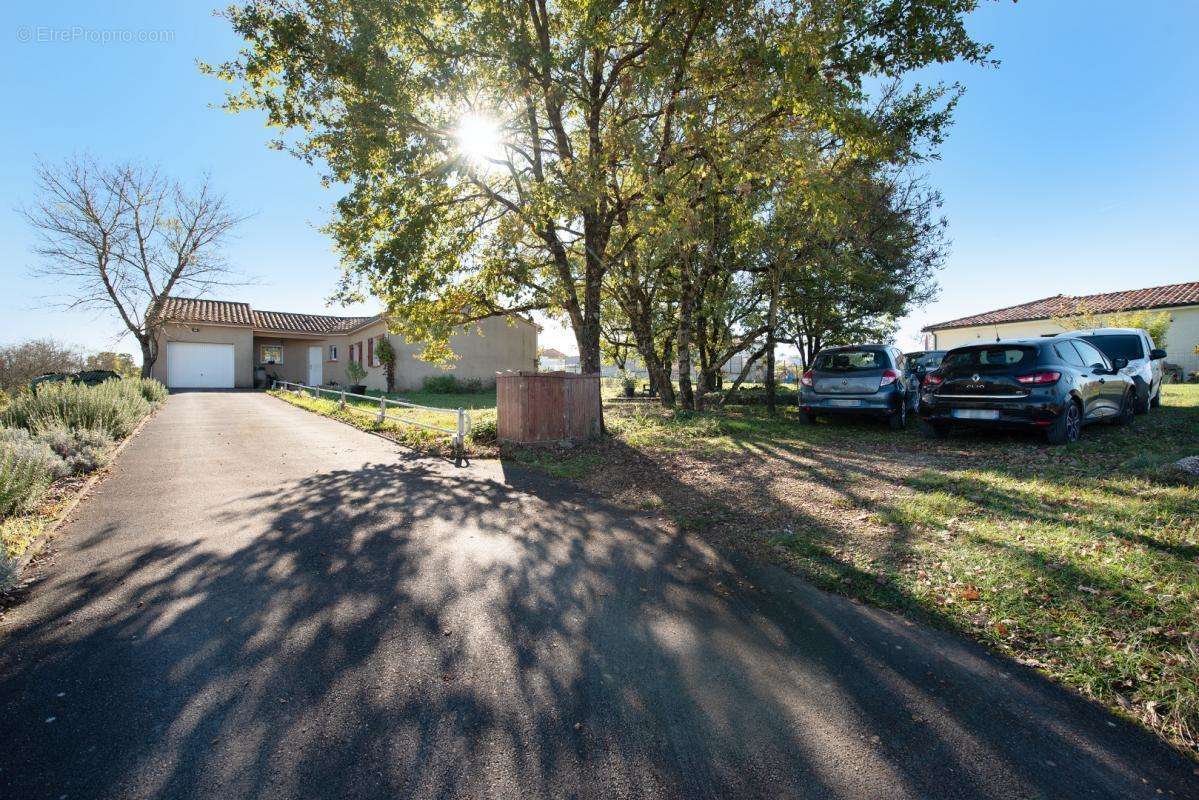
[0,393,1199,800]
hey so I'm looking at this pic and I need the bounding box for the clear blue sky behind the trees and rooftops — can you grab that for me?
[0,0,1199,351]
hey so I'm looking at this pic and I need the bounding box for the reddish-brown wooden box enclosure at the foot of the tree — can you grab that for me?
[495,371,601,444]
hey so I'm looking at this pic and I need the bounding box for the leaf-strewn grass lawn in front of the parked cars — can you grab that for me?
[544,385,1199,754]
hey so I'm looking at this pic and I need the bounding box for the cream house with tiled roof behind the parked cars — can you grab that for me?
[922,281,1199,374]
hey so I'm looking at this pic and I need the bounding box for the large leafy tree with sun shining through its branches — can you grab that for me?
[206,0,988,386]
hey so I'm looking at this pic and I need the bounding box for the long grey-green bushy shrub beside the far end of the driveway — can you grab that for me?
[2,379,151,439]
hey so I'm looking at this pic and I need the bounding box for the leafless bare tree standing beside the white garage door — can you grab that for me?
[24,157,243,375]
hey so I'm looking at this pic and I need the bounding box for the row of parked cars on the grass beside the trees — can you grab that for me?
[800,329,1165,444]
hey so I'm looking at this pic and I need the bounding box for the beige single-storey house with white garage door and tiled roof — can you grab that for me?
[151,297,537,390]
